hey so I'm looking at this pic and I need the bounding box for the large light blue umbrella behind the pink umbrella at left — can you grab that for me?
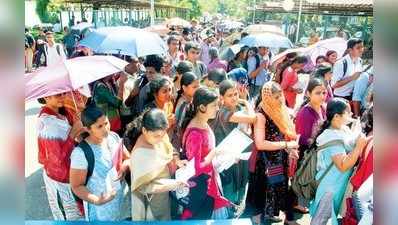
[80,26,167,57]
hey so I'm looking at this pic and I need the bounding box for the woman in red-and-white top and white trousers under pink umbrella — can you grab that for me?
[37,93,83,220]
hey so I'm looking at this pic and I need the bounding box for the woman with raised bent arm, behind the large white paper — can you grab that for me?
[211,80,256,205]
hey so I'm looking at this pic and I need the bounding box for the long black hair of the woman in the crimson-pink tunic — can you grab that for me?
[181,87,218,131]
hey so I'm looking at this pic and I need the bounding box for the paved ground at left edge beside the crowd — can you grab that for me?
[25,92,316,225]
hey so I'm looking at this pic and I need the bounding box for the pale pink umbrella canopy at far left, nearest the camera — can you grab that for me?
[25,56,128,101]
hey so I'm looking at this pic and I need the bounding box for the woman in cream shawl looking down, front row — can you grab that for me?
[126,109,184,221]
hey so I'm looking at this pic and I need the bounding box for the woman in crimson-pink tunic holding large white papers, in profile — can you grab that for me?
[181,88,230,219]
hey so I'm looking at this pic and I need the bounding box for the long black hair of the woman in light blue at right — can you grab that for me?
[310,98,350,149]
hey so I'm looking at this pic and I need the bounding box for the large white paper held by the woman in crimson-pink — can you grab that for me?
[213,128,253,173]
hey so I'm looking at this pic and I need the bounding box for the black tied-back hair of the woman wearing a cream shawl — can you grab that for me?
[123,109,168,151]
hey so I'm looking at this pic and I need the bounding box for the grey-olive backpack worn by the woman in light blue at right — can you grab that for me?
[292,140,344,200]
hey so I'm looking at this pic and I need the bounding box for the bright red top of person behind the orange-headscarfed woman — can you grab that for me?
[281,66,298,108]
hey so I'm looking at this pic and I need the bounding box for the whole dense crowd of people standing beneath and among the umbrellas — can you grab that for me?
[30,18,374,225]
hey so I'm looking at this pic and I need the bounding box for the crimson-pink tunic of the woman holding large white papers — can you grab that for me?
[182,127,230,219]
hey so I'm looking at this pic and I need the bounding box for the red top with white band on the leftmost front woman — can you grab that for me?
[38,106,75,183]
